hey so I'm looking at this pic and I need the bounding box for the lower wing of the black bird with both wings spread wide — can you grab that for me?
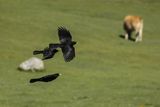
[62,45,75,62]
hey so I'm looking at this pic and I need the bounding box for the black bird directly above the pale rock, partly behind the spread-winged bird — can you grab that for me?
[33,44,60,60]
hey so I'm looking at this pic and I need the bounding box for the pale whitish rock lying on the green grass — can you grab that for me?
[18,57,44,71]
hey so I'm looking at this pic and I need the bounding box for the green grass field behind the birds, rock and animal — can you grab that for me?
[0,0,160,107]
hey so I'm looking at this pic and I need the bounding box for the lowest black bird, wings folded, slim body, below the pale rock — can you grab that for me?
[30,73,61,83]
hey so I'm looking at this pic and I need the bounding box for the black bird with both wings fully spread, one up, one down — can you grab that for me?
[58,27,76,62]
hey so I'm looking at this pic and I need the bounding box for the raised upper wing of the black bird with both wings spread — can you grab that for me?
[58,27,72,43]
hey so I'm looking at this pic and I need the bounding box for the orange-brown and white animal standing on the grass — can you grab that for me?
[123,15,143,42]
